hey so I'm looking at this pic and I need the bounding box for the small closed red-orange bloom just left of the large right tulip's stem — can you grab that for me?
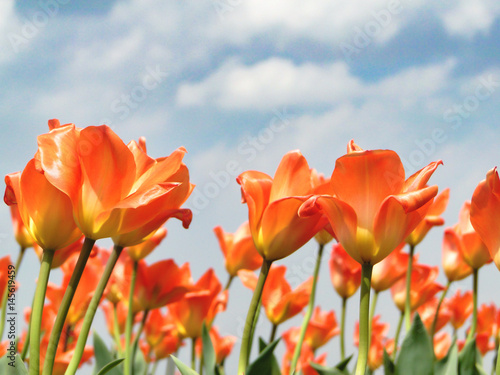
[329,244,361,298]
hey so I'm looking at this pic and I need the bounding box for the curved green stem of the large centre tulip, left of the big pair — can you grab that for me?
[238,259,273,375]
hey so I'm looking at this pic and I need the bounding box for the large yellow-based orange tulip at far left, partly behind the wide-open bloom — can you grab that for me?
[4,159,81,250]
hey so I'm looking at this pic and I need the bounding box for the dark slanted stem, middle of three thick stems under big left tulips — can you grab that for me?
[43,237,95,375]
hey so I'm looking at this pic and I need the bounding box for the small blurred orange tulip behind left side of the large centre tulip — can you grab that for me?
[214,221,262,277]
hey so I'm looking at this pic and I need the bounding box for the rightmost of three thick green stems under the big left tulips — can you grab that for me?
[65,245,123,375]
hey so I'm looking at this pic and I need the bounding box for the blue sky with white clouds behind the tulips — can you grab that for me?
[0,0,500,374]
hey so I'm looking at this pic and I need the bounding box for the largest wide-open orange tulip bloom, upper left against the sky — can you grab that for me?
[37,124,193,247]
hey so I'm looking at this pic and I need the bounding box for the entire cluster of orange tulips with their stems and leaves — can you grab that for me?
[0,120,500,375]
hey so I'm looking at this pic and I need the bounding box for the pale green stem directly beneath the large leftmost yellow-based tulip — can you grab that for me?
[29,250,54,375]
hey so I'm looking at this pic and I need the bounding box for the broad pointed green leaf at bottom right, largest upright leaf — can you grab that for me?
[395,314,434,375]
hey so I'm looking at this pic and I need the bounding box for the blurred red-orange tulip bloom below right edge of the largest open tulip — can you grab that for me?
[132,259,192,313]
